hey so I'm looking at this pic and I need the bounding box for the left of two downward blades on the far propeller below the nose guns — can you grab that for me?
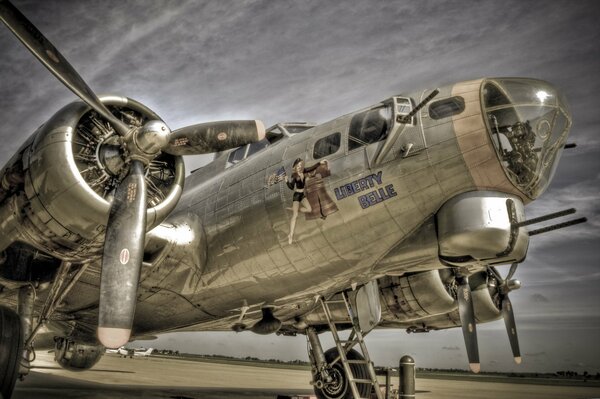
[458,277,481,373]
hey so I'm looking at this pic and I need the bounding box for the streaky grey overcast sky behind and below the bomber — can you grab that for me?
[0,0,600,373]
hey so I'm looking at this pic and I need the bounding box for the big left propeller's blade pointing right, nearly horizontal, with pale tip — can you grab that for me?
[163,120,265,155]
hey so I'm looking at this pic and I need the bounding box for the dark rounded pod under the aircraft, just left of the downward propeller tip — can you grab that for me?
[54,338,106,371]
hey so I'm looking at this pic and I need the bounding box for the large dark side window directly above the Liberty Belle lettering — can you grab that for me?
[348,105,392,151]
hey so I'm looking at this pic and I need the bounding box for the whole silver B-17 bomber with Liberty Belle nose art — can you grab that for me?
[0,0,585,399]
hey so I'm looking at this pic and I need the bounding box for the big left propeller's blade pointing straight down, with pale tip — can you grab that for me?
[98,160,146,348]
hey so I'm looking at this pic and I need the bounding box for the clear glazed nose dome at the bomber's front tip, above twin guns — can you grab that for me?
[481,78,571,199]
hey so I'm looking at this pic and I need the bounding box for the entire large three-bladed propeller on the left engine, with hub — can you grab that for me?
[0,0,265,348]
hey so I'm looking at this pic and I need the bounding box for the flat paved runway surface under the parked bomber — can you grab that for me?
[13,353,600,399]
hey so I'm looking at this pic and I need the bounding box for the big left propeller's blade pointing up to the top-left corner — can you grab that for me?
[0,0,129,136]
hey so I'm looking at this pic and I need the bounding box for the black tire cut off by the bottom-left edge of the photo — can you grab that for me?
[0,306,23,399]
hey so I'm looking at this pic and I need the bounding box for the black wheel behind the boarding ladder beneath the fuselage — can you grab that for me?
[314,348,371,399]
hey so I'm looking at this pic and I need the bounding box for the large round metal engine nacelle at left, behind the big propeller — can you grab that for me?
[0,97,185,261]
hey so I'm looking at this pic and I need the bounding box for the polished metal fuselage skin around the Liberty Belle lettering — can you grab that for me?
[125,81,526,333]
